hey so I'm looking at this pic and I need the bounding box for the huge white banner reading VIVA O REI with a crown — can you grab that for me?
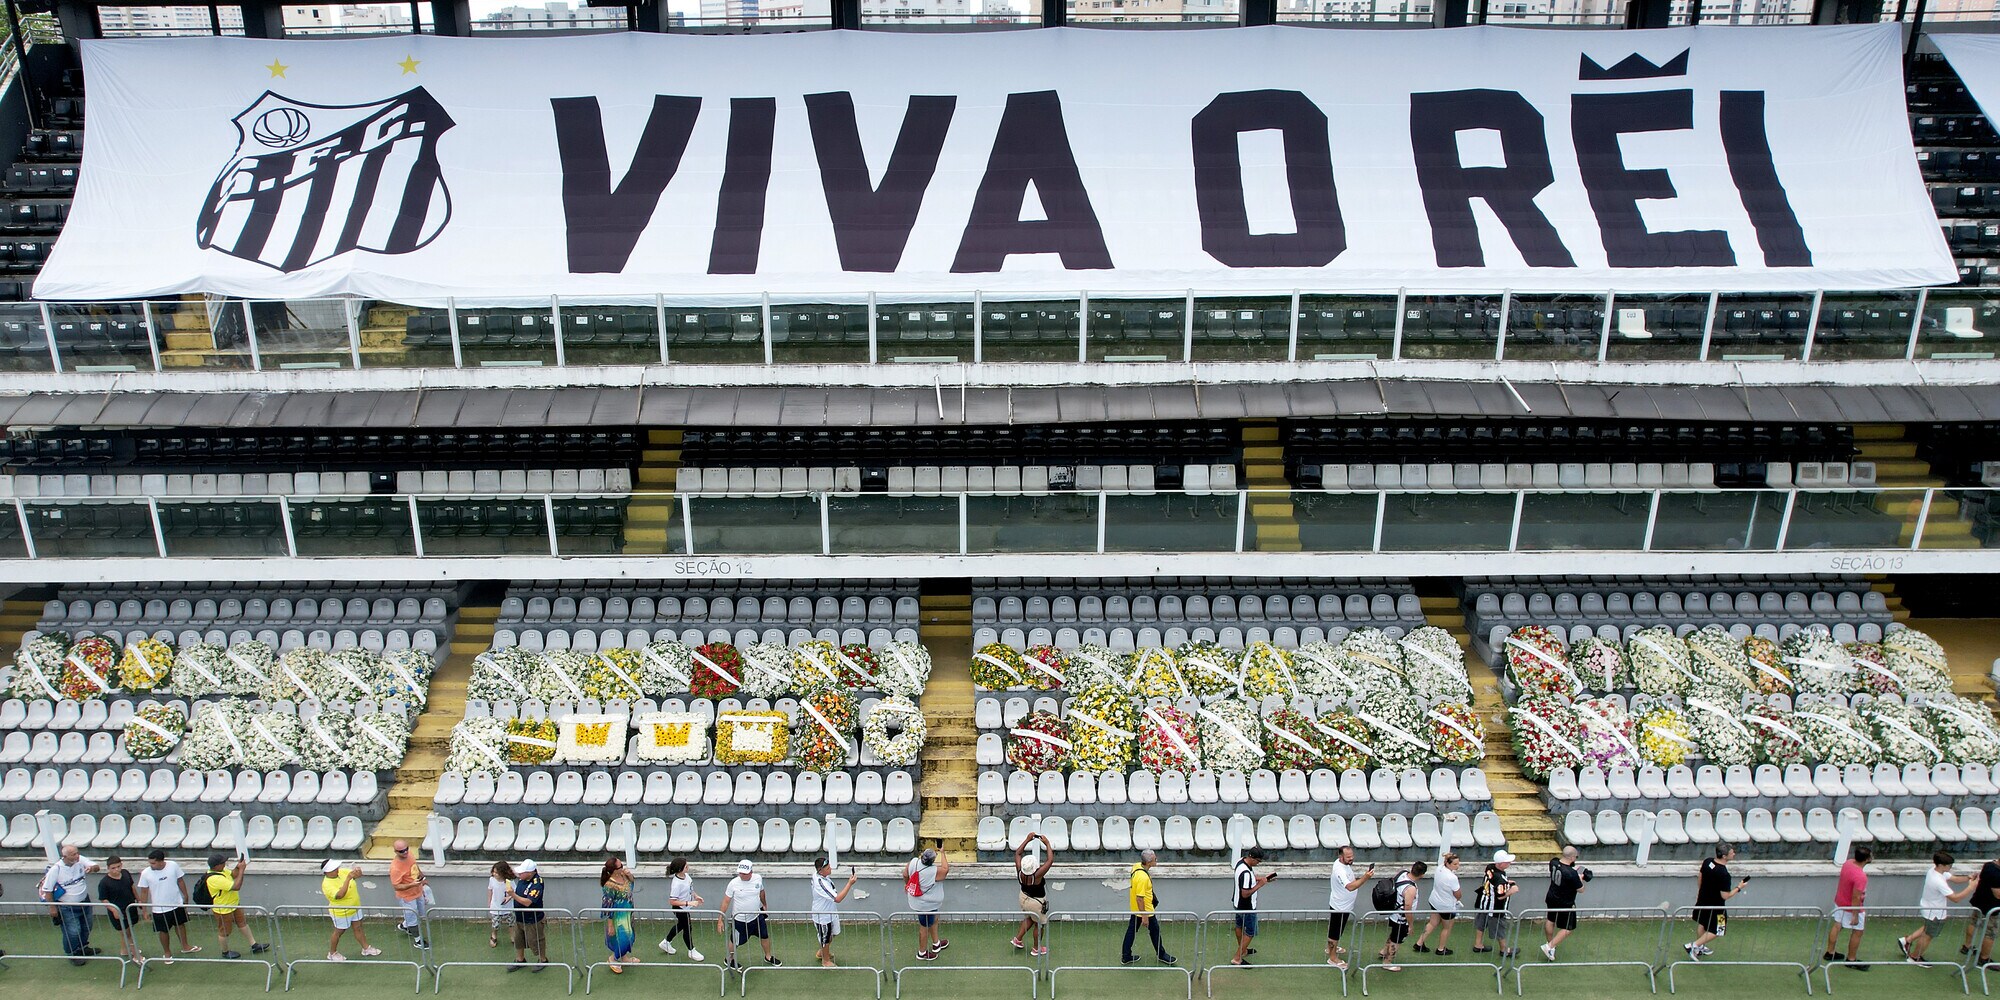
[36,24,1956,304]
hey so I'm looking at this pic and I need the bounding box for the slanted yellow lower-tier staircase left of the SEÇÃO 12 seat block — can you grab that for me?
[364,590,500,860]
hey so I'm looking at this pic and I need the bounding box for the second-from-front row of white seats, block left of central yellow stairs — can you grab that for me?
[436,768,916,806]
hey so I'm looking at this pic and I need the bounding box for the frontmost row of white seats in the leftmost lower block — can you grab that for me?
[0,812,368,856]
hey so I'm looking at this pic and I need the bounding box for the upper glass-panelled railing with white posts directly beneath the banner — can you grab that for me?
[15,288,2000,372]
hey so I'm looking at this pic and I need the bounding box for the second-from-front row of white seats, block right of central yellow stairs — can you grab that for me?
[978,768,1492,806]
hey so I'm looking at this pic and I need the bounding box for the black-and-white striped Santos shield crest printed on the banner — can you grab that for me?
[194,86,452,274]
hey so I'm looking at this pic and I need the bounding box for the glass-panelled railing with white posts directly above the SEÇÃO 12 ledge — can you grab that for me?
[0,484,2000,572]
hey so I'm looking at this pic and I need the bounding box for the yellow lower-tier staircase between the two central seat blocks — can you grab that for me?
[916,580,980,860]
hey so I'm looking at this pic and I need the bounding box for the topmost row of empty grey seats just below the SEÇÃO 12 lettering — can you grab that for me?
[498,594,920,626]
